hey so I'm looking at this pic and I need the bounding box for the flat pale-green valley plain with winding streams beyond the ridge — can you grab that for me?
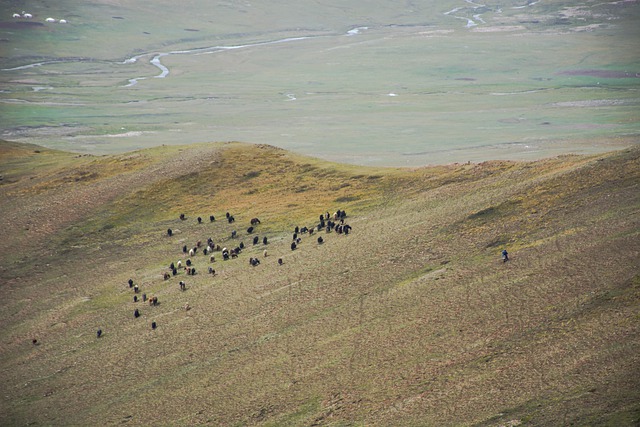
[0,1,640,166]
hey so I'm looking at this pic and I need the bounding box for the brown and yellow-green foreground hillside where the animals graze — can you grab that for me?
[0,142,640,426]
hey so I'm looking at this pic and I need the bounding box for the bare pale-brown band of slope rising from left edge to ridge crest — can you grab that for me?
[0,146,220,260]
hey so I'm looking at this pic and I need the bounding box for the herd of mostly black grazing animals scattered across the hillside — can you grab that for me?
[95,210,352,338]
